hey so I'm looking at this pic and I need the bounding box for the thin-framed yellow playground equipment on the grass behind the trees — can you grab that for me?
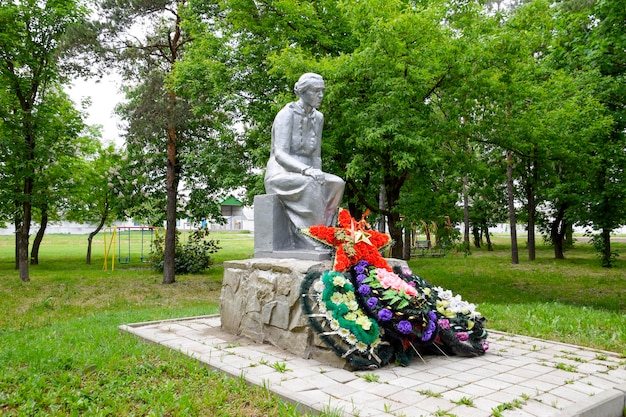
[102,226,156,271]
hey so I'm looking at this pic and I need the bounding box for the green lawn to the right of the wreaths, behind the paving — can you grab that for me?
[409,238,626,355]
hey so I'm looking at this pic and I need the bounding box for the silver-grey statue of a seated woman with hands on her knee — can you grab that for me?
[265,73,345,249]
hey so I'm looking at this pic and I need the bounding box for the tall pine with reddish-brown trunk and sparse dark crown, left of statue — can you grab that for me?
[99,0,191,284]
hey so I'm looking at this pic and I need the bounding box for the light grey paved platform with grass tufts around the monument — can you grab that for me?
[121,316,626,417]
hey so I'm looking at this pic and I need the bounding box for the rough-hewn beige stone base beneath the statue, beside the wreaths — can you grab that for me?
[220,258,346,368]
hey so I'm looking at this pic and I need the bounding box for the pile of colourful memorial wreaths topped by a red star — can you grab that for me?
[303,210,489,368]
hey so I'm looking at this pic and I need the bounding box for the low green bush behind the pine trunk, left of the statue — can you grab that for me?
[150,228,221,274]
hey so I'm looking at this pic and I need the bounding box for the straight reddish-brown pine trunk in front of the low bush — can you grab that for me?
[163,91,179,284]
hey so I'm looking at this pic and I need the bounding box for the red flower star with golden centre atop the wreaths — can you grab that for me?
[300,209,391,272]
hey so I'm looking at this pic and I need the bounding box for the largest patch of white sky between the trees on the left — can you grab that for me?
[68,75,124,147]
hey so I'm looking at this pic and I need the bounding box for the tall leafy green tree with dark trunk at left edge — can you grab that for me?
[0,0,87,281]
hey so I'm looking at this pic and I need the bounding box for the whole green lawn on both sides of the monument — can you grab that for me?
[0,233,626,417]
